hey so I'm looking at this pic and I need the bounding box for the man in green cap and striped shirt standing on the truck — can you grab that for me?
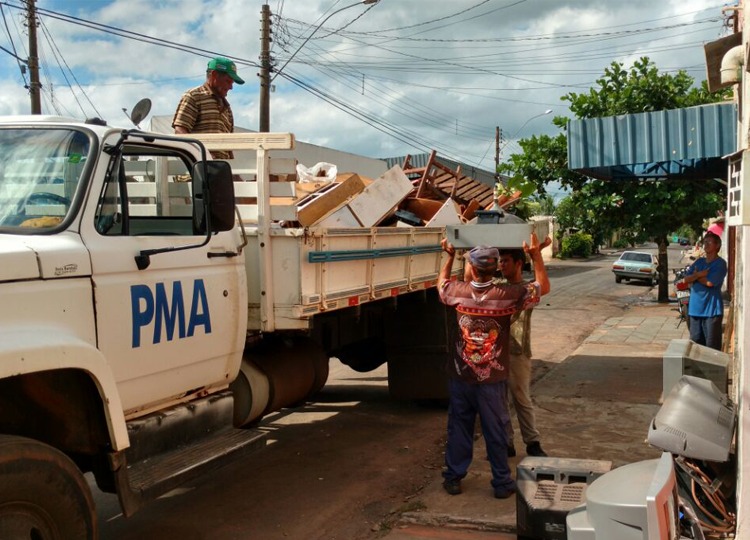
[172,57,245,159]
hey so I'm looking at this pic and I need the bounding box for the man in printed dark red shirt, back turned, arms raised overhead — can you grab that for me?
[438,234,546,499]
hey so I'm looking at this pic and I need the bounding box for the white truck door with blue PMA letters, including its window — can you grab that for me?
[82,142,247,415]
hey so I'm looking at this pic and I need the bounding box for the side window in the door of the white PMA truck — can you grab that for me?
[96,145,195,236]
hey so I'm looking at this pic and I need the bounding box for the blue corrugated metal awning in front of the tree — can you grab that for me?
[568,103,737,180]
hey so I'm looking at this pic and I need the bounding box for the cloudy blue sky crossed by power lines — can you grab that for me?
[0,0,736,169]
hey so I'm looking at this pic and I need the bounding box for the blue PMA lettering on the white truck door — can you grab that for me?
[130,279,211,349]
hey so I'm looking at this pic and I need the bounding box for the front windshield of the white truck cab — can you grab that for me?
[0,128,91,232]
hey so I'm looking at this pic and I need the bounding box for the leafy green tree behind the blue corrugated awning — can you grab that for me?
[501,57,726,302]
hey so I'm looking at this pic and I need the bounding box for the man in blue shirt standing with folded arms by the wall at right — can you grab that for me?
[685,233,727,351]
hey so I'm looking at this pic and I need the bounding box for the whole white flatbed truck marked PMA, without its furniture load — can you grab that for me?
[0,116,460,540]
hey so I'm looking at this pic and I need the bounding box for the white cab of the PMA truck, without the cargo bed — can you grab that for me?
[0,116,252,538]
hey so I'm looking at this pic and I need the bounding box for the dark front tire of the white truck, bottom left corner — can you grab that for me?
[0,435,98,540]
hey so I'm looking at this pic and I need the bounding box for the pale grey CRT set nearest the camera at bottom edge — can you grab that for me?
[566,452,680,540]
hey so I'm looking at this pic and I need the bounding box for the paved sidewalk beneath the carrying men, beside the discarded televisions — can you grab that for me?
[386,302,688,540]
